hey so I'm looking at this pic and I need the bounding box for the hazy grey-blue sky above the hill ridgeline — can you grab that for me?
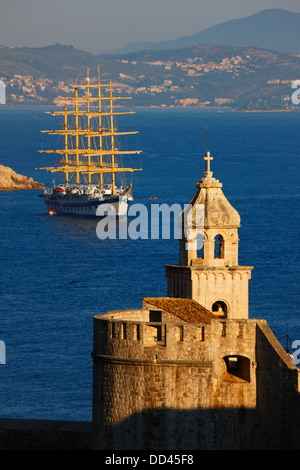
[0,0,300,54]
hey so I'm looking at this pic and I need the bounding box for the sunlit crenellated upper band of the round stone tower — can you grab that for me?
[93,309,261,373]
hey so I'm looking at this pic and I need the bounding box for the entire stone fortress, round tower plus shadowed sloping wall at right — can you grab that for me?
[93,309,299,450]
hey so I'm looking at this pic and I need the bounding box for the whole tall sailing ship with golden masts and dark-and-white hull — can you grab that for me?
[38,69,141,217]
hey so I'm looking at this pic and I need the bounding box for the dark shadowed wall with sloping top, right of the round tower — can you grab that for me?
[257,324,300,450]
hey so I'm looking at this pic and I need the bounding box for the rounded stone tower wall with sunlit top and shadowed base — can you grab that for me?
[93,315,256,450]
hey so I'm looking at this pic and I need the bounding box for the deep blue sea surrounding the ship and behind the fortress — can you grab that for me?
[0,106,300,421]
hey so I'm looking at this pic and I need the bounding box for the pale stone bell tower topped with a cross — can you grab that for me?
[166,143,253,319]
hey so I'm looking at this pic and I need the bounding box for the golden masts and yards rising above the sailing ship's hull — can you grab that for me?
[38,69,141,190]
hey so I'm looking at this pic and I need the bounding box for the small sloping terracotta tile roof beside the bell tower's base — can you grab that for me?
[144,297,216,323]
